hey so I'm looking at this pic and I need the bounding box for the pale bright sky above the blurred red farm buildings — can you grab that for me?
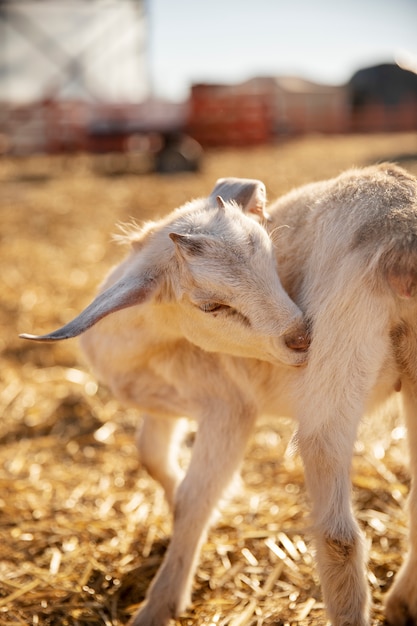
[147,0,417,100]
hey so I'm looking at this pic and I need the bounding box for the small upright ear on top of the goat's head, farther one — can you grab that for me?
[210,178,270,220]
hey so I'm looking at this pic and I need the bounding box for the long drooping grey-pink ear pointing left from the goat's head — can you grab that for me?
[20,275,157,341]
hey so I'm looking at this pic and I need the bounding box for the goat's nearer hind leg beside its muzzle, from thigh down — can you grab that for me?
[299,281,389,626]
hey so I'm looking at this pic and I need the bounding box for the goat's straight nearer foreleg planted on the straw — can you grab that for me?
[130,400,255,626]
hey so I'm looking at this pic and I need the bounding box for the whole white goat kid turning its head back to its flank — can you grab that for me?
[22,165,417,626]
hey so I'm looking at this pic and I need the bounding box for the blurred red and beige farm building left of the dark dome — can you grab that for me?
[187,77,349,146]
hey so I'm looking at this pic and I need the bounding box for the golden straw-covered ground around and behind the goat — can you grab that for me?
[0,134,417,626]
